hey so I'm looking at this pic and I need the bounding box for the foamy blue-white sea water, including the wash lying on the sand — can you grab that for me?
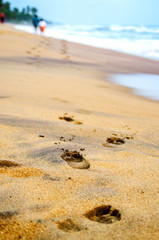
[16,24,159,100]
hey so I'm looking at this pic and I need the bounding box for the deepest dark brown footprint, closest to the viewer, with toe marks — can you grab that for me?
[84,205,121,224]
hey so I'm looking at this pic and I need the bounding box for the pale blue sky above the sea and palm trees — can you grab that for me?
[8,0,159,25]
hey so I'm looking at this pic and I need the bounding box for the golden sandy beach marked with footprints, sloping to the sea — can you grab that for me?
[0,25,159,240]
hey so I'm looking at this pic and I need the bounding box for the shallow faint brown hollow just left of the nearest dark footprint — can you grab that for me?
[57,218,84,232]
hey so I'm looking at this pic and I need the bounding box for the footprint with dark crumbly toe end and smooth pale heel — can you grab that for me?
[61,150,90,169]
